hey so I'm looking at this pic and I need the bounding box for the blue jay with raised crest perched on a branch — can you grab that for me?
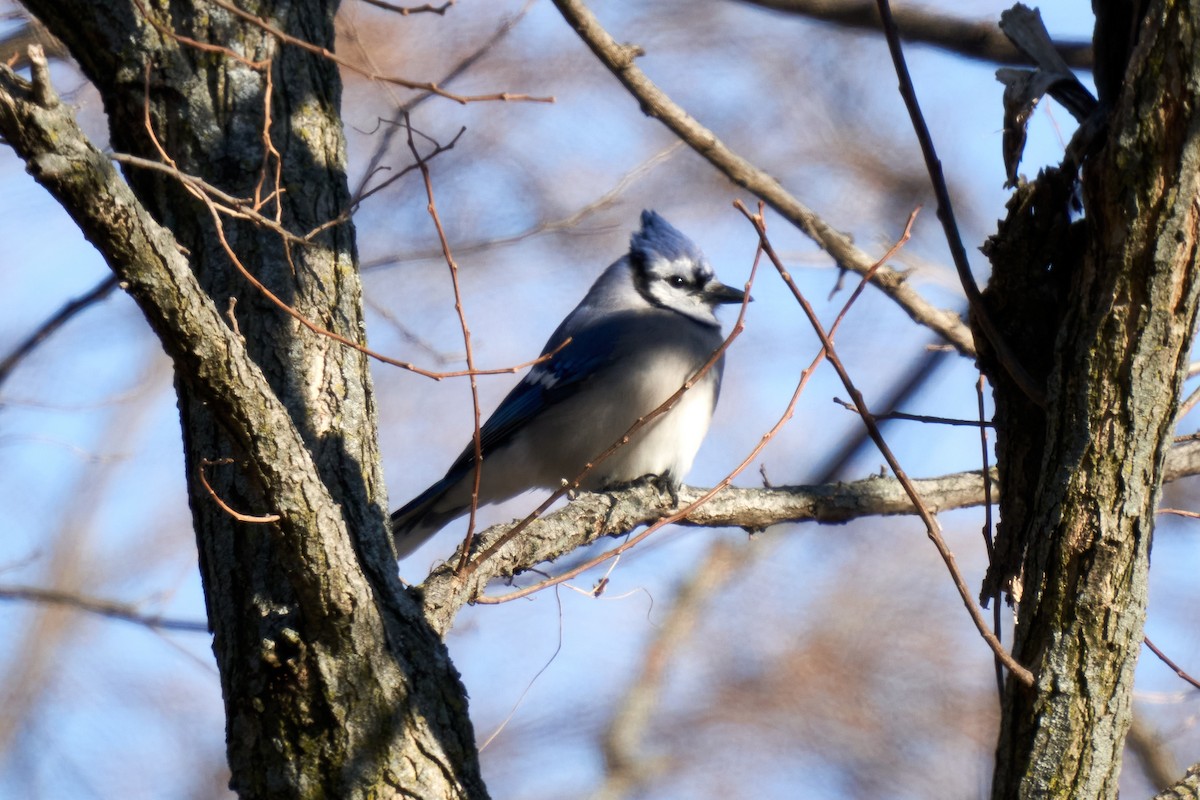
[391,211,744,558]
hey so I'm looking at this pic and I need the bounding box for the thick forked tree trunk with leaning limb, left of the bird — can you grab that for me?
[2,0,486,798]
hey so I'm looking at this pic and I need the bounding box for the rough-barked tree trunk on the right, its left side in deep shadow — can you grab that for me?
[984,1,1200,800]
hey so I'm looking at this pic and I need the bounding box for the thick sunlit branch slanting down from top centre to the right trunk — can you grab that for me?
[554,0,974,357]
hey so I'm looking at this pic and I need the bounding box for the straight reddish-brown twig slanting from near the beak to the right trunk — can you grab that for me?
[739,206,1033,686]
